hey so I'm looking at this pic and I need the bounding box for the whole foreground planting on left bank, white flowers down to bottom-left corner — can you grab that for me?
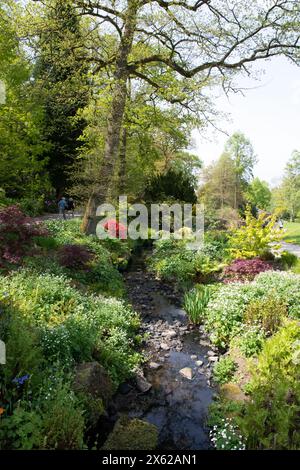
[0,269,140,449]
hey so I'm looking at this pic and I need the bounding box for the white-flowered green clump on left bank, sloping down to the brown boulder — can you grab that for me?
[0,270,139,383]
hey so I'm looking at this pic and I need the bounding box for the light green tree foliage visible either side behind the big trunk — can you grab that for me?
[72,80,201,199]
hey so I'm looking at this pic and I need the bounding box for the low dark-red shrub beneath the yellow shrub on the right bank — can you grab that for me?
[223,258,273,283]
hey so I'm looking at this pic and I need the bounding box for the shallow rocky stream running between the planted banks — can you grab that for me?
[99,253,217,450]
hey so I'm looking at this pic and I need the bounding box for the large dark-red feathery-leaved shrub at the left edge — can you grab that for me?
[0,206,48,264]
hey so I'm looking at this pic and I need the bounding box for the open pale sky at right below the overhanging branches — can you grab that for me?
[193,57,300,186]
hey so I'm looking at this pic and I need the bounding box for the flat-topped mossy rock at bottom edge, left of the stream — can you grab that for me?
[102,416,158,450]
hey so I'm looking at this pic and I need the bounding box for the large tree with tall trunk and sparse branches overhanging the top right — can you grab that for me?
[28,0,300,232]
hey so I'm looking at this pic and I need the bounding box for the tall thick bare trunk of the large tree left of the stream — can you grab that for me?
[82,0,138,234]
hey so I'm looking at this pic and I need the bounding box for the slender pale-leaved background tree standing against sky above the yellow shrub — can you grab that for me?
[225,132,257,209]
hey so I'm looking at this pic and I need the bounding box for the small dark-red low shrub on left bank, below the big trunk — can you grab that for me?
[58,245,95,269]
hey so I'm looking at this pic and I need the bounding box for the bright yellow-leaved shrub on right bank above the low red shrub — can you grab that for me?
[229,207,283,259]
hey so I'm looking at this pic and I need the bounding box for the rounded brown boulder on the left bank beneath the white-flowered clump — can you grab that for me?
[73,362,113,403]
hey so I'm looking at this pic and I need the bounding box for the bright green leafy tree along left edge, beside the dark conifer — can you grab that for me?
[0,1,48,198]
